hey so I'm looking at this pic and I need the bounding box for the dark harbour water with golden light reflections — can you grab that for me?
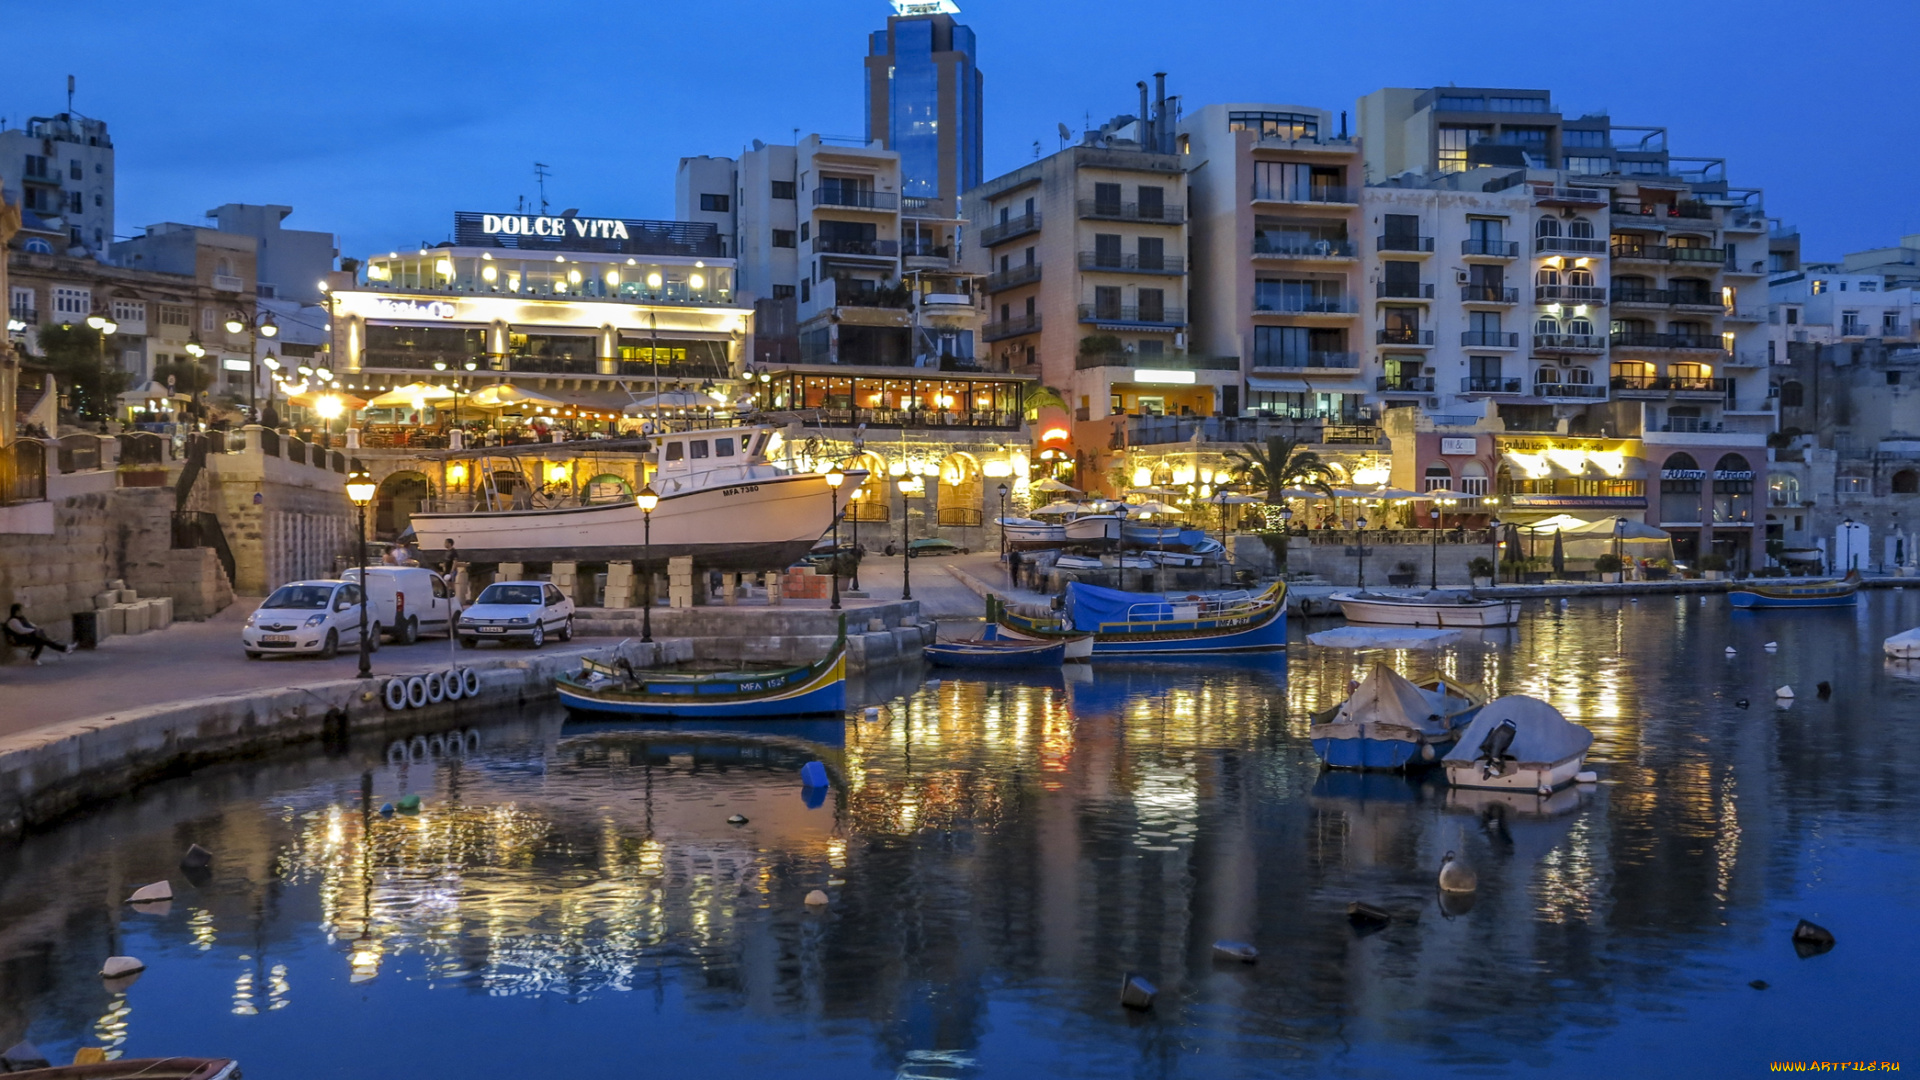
[0,590,1920,1080]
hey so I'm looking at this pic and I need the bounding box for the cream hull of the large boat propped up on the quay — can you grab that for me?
[413,473,833,571]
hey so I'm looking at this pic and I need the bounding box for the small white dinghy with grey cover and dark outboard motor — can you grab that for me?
[1442,694,1594,792]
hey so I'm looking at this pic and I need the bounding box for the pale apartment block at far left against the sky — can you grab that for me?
[0,111,113,259]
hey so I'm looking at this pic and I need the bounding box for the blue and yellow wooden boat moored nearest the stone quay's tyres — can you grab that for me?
[555,617,847,719]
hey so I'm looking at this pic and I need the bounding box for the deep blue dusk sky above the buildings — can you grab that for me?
[0,0,1920,258]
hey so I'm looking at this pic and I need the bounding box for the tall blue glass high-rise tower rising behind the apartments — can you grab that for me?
[866,0,981,208]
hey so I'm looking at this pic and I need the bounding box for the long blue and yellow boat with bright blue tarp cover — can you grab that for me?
[989,582,1286,659]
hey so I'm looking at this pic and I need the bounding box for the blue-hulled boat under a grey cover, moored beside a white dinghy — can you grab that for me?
[1308,663,1484,771]
